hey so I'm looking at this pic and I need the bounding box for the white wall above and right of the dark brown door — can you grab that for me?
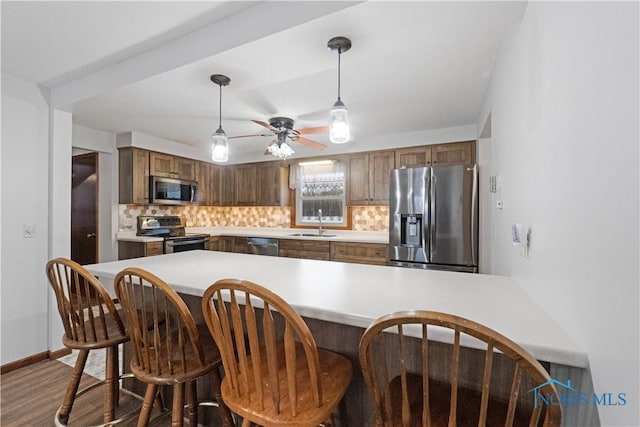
[73,125,118,262]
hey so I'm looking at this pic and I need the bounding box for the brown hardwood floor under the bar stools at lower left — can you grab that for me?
[0,360,230,427]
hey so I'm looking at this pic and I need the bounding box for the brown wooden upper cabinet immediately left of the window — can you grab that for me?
[256,161,289,206]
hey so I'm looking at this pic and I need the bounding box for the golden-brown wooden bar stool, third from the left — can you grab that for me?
[202,279,352,427]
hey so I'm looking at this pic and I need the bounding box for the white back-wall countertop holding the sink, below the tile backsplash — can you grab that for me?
[116,227,389,244]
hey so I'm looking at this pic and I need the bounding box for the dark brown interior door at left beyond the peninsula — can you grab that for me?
[71,153,98,264]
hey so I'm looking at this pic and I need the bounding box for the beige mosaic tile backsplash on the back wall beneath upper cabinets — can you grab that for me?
[118,205,389,231]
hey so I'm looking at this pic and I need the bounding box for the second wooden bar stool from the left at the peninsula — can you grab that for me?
[114,268,234,427]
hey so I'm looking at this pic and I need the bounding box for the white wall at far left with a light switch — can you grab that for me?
[0,75,49,364]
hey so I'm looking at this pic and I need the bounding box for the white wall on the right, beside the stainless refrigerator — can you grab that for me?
[479,2,640,426]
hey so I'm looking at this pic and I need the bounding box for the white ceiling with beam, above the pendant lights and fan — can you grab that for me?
[1,1,526,163]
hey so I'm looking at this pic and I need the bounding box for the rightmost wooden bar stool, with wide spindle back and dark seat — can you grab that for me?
[359,311,562,427]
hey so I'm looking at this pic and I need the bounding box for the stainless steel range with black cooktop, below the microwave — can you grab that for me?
[136,215,209,254]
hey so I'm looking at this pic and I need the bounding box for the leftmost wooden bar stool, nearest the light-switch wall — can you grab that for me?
[46,258,137,426]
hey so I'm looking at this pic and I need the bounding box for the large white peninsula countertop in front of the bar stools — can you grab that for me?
[86,251,588,368]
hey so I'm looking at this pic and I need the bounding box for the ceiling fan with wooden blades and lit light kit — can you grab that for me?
[229,117,329,157]
